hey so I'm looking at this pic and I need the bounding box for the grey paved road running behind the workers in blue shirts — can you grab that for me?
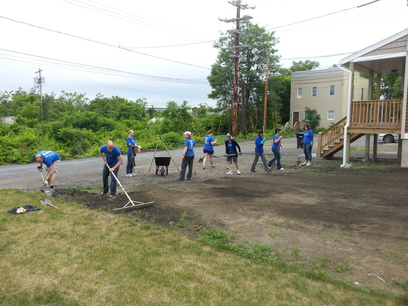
[0,137,397,190]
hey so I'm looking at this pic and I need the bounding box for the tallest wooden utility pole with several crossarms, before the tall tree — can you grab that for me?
[219,0,255,136]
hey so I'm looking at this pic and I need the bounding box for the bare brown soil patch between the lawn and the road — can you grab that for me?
[56,154,408,292]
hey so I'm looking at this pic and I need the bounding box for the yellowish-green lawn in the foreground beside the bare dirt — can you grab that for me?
[0,190,408,305]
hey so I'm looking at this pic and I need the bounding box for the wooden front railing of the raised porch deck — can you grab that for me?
[350,100,402,128]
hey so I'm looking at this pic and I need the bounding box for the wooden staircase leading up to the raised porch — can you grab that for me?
[316,117,364,158]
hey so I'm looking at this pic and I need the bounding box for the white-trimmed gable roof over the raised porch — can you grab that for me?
[340,29,408,73]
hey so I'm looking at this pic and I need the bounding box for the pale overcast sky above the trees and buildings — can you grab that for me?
[0,0,408,106]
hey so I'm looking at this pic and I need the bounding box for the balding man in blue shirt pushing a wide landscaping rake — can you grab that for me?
[99,140,123,199]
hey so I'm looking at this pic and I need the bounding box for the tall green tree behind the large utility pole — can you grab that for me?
[208,21,279,134]
